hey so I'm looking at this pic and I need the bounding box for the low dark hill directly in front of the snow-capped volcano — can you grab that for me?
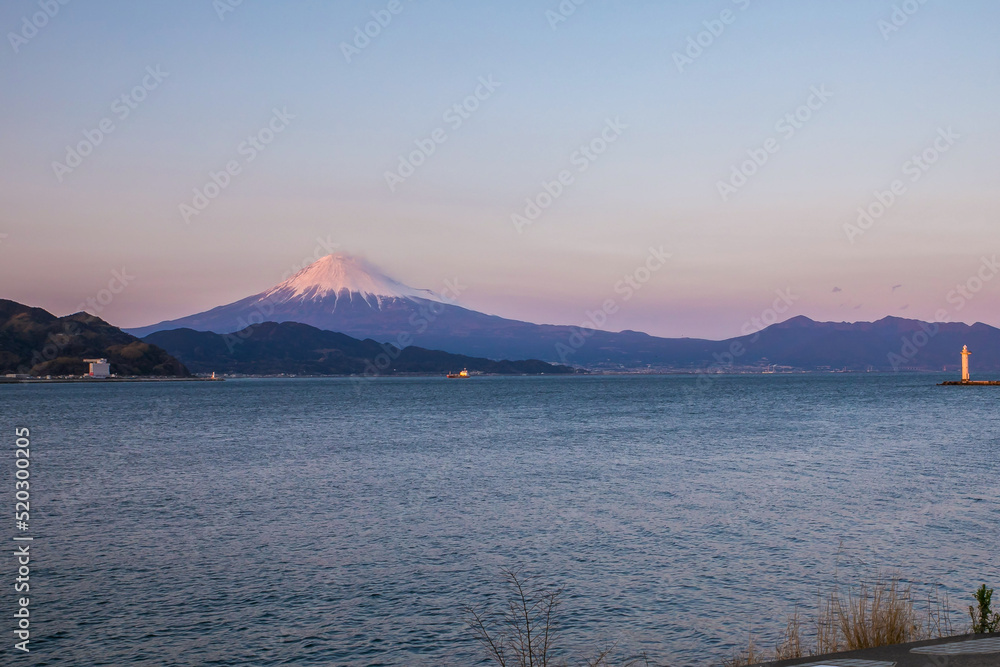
[145,322,576,375]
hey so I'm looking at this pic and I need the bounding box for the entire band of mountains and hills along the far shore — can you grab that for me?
[0,255,1000,379]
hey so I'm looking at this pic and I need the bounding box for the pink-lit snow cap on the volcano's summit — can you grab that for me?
[261,253,440,301]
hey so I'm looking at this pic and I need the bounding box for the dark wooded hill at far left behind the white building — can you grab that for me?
[0,299,190,377]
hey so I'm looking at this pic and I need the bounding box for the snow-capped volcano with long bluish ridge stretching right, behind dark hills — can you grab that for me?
[129,254,1000,371]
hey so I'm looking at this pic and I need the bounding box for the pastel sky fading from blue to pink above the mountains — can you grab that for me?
[0,0,1000,338]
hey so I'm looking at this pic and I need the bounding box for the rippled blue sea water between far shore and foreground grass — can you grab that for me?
[0,374,1000,665]
